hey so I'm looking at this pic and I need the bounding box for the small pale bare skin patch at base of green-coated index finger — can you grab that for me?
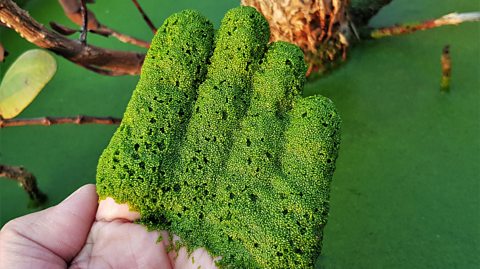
[96,197,140,222]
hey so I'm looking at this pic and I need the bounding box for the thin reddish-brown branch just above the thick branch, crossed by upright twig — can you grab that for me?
[58,0,150,48]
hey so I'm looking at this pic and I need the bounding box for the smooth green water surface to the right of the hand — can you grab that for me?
[312,0,480,269]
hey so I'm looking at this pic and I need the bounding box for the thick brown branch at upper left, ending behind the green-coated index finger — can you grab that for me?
[0,0,145,75]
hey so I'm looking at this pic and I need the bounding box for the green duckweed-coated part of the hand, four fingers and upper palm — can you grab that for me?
[97,7,339,268]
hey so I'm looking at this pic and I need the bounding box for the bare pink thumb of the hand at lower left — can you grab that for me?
[0,184,98,268]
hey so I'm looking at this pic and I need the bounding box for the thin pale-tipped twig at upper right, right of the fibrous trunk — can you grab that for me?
[370,12,480,38]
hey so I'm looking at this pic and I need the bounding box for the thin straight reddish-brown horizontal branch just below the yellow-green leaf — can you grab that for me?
[0,115,122,128]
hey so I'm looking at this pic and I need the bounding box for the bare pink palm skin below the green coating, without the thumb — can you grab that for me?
[69,198,215,269]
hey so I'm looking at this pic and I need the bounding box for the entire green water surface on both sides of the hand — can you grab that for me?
[0,0,480,269]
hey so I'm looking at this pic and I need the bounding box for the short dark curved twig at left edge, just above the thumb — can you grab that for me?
[0,164,47,207]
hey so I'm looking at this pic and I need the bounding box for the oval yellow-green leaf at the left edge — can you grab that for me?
[0,49,57,119]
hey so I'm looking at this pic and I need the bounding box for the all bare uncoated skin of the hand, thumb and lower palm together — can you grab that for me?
[0,184,216,269]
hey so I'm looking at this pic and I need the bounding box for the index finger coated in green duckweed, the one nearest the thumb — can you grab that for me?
[97,11,213,215]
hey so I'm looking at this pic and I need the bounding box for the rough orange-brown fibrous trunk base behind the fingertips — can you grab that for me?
[242,0,351,75]
